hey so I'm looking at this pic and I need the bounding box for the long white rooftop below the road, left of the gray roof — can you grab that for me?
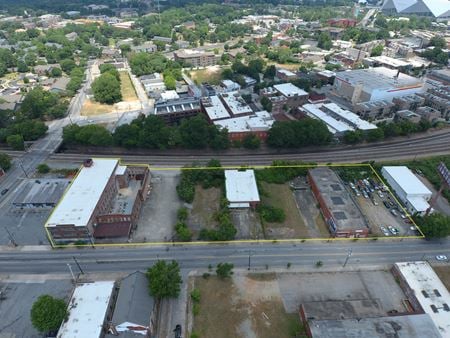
[57,282,114,338]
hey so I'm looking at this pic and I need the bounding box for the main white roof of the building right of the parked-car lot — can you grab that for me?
[382,166,431,196]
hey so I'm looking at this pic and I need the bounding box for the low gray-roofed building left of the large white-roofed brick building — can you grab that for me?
[13,179,69,209]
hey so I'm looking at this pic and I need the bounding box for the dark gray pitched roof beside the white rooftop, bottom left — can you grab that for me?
[105,271,155,338]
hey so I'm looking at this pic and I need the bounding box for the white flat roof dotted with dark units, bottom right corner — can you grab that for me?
[395,261,450,338]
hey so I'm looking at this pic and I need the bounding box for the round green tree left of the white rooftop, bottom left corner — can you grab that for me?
[31,295,67,333]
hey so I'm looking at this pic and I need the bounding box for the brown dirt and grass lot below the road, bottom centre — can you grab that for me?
[193,274,302,338]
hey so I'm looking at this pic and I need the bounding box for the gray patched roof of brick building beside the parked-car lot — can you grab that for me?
[309,167,368,231]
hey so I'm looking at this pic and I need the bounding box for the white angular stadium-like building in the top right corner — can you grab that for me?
[381,0,450,20]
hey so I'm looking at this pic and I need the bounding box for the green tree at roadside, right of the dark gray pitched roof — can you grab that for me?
[147,260,183,299]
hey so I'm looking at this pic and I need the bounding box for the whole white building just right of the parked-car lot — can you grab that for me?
[381,166,432,215]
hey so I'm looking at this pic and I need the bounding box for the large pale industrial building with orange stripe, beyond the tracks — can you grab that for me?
[333,67,423,104]
